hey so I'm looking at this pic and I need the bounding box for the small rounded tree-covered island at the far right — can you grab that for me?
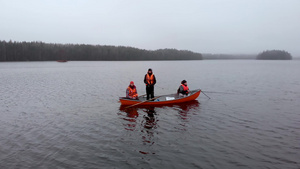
[256,50,292,60]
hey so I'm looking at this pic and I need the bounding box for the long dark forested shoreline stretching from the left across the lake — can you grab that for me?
[0,41,202,61]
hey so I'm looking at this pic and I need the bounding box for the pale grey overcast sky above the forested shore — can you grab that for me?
[0,0,300,57]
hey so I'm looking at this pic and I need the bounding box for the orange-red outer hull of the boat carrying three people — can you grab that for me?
[120,89,201,106]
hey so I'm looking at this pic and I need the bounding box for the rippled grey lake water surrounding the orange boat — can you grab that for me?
[0,60,300,169]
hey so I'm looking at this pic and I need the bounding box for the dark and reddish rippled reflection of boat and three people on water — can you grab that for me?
[119,100,200,154]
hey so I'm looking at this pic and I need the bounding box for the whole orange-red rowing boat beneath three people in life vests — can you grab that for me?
[119,89,201,106]
